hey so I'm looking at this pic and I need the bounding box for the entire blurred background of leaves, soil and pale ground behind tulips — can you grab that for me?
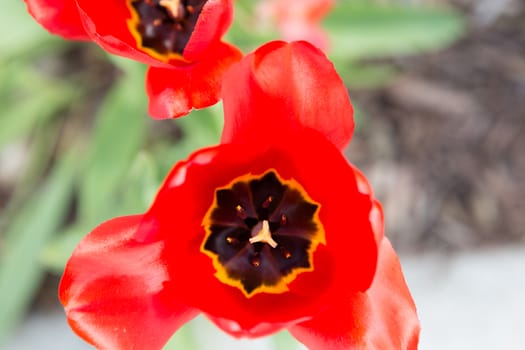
[0,0,525,350]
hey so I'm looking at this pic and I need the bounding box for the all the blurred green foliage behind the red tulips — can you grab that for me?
[0,0,463,349]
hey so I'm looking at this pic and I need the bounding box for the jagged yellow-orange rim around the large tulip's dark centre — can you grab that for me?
[200,168,326,299]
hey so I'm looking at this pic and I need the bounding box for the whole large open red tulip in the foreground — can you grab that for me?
[59,42,419,350]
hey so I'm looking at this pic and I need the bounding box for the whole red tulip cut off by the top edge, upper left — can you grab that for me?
[24,0,242,119]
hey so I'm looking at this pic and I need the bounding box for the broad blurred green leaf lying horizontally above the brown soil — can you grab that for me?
[324,1,464,60]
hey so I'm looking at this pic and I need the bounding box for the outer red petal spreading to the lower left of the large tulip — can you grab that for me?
[59,215,197,350]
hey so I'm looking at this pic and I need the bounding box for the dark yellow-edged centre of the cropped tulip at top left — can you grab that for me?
[128,0,207,61]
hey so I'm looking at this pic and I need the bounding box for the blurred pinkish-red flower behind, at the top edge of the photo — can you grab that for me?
[258,0,335,51]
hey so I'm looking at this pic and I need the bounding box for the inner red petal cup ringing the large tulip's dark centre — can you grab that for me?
[146,130,377,336]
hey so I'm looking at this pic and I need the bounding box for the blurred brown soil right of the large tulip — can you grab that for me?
[348,0,525,249]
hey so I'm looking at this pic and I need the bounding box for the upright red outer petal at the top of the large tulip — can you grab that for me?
[222,42,354,148]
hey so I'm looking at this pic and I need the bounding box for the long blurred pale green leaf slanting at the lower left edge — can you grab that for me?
[0,153,75,344]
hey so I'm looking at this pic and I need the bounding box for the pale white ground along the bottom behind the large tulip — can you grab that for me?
[5,245,525,350]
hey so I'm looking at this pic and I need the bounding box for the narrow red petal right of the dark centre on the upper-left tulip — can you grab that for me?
[184,0,233,62]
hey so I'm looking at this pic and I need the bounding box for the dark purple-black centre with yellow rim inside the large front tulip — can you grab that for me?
[201,169,325,297]
